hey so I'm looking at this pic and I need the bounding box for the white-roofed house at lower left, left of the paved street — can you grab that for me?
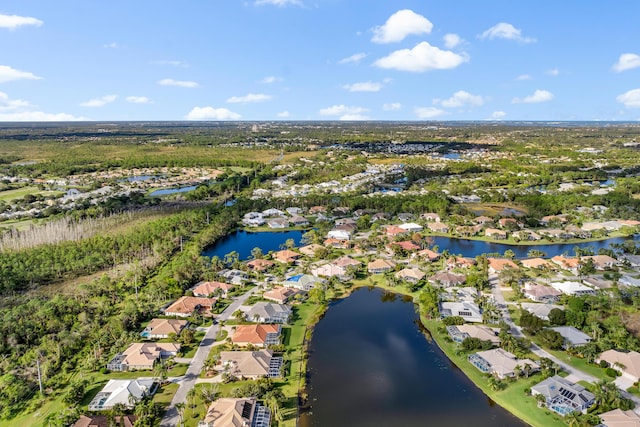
[89,378,157,411]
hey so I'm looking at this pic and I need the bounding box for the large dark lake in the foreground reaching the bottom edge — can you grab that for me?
[300,288,526,427]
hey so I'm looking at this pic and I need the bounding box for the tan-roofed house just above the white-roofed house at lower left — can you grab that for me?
[107,342,180,371]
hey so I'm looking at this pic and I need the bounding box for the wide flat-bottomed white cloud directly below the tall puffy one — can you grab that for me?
[373,42,469,73]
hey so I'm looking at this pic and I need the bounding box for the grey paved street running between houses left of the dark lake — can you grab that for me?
[160,286,258,427]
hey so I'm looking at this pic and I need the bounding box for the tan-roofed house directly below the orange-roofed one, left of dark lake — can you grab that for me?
[220,350,282,380]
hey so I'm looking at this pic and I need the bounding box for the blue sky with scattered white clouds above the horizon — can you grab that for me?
[0,0,640,121]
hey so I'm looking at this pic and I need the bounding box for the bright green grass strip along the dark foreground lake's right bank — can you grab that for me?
[422,318,566,427]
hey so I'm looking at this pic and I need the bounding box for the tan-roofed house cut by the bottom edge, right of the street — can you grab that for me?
[198,397,271,427]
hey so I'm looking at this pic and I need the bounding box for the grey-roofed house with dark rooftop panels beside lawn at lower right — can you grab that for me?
[531,375,596,417]
